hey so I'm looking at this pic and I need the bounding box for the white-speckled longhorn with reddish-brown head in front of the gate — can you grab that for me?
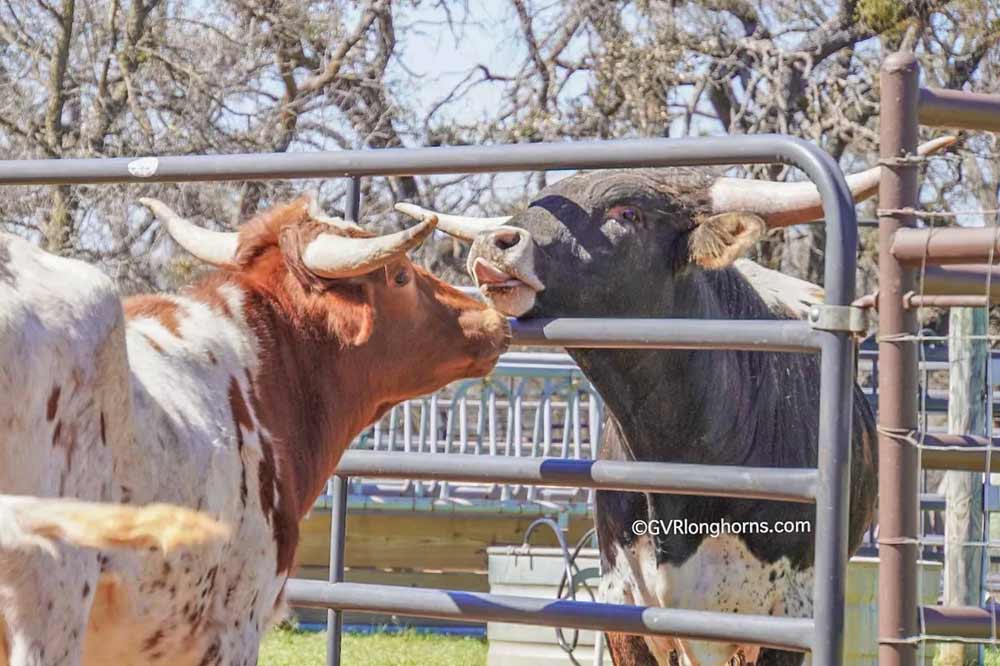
[0,198,509,666]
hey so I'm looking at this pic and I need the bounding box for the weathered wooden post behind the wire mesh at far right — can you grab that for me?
[938,308,988,666]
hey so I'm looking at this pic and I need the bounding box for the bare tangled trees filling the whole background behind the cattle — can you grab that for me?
[0,0,1000,289]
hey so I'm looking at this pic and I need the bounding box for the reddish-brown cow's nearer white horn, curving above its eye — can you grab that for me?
[302,215,437,278]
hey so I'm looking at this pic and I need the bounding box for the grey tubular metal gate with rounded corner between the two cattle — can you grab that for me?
[0,135,857,666]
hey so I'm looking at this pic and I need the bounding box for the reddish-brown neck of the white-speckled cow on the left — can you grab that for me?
[217,272,381,520]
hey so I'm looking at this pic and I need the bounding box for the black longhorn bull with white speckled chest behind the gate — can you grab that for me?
[397,139,951,666]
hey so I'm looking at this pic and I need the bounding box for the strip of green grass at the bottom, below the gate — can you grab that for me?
[259,628,486,666]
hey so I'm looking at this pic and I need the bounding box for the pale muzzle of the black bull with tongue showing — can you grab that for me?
[468,226,545,317]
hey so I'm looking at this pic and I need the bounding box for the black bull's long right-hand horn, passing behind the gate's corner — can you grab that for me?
[709,136,958,228]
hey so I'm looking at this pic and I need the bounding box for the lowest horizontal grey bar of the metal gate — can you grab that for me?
[285,579,813,652]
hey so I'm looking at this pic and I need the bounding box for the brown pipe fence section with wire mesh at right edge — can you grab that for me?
[877,53,1000,666]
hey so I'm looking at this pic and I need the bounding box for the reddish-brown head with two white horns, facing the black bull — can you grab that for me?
[141,197,509,400]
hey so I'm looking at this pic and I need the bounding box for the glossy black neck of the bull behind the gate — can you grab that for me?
[571,269,792,464]
